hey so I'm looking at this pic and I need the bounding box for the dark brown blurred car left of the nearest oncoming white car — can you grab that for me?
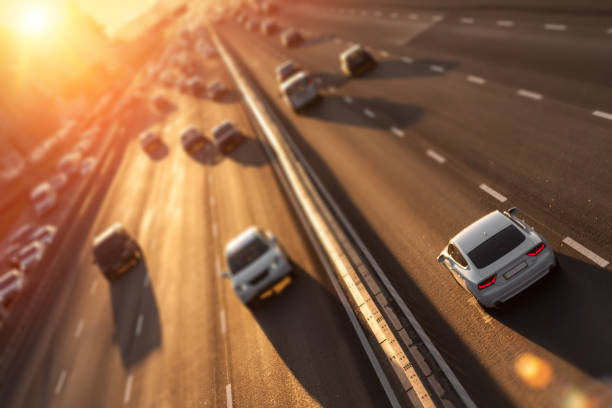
[93,222,142,281]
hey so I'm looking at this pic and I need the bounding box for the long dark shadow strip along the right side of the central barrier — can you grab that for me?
[262,96,515,408]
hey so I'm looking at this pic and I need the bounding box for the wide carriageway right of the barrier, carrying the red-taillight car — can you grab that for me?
[217,3,612,407]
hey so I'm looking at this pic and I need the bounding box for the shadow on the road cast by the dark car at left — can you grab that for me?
[109,255,162,369]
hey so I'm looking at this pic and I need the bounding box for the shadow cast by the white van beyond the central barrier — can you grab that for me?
[302,94,424,130]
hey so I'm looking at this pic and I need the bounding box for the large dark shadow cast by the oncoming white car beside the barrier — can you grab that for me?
[247,264,388,407]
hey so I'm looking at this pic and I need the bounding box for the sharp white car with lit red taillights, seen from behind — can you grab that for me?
[438,208,557,308]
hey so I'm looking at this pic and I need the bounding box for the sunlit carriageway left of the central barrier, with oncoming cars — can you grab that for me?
[0,26,388,407]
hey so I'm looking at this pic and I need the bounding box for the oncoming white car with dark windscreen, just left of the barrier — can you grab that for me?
[223,227,292,306]
